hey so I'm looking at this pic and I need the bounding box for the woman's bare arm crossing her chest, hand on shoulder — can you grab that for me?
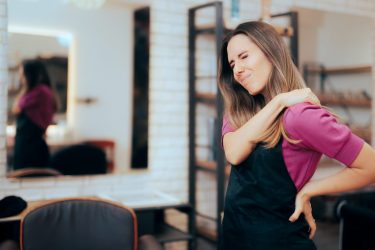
[223,88,320,165]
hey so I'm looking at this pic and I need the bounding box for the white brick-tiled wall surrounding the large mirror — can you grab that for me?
[0,0,375,249]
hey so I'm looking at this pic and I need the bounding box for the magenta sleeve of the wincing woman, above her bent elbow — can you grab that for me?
[284,103,364,166]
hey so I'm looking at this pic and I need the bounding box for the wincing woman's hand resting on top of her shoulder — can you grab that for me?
[278,88,321,107]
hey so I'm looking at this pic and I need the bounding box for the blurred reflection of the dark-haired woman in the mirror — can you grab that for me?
[12,60,56,170]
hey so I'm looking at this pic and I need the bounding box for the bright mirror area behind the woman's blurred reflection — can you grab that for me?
[8,30,71,125]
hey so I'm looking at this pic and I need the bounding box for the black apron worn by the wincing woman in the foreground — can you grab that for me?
[221,139,316,250]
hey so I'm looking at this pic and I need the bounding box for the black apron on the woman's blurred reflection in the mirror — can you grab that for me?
[13,113,49,170]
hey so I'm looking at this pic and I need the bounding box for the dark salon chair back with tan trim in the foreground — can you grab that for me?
[20,198,163,250]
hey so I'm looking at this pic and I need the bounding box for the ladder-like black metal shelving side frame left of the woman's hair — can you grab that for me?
[189,2,226,244]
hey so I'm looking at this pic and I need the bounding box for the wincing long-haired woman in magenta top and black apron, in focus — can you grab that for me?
[219,22,375,250]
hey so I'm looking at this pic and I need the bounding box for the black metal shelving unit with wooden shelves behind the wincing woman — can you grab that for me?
[189,1,298,246]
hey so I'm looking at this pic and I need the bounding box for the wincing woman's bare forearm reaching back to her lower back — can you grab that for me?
[300,143,375,198]
